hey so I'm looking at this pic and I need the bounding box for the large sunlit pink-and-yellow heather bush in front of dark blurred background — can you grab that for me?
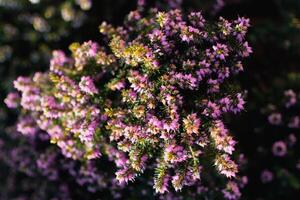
[5,9,252,195]
